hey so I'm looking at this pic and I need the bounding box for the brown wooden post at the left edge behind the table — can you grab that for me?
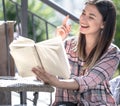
[0,21,15,105]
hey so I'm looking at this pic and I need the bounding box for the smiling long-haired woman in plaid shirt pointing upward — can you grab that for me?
[32,0,120,106]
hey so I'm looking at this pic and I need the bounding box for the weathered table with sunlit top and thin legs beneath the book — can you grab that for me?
[0,76,54,105]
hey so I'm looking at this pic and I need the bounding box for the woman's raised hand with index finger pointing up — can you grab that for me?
[56,15,71,40]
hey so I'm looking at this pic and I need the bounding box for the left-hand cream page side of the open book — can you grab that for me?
[9,38,40,77]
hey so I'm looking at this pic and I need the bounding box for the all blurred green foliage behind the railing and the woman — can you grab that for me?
[0,0,120,44]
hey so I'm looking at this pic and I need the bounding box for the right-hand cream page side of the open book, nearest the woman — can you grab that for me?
[36,37,70,79]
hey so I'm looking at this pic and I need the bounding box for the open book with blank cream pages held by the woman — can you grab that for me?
[9,36,70,79]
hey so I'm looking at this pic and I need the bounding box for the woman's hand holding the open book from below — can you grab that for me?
[32,66,59,86]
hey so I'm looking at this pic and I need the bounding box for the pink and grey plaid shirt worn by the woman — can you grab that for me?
[54,37,120,106]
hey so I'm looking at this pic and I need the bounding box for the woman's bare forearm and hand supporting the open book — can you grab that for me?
[32,66,79,90]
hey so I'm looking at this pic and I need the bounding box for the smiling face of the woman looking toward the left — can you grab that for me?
[80,4,104,36]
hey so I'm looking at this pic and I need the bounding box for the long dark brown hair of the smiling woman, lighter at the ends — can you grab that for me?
[77,0,116,68]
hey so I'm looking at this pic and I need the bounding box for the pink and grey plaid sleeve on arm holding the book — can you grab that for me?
[74,44,120,92]
